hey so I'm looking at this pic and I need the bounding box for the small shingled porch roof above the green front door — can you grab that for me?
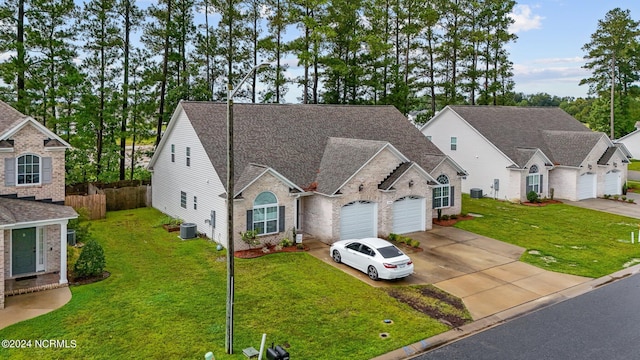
[0,197,78,225]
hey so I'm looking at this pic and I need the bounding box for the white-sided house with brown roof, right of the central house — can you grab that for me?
[421,106,629,202]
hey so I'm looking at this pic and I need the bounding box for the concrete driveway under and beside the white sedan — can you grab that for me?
[310,225,591,320]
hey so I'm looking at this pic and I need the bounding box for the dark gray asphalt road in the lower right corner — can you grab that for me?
[414,274,640,360]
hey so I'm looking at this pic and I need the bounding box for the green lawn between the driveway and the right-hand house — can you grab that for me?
[455,195,640,278]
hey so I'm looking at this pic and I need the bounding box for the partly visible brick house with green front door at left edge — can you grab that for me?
[0,101,78,309]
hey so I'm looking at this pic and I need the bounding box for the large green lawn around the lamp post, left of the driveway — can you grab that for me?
[0,209,447,360]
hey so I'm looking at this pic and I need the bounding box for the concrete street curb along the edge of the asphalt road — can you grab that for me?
[371,265,640,360]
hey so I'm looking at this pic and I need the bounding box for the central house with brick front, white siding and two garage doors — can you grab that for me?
[149,101,466,249]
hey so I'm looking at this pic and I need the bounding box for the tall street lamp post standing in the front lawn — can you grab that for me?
[225,63,269,354]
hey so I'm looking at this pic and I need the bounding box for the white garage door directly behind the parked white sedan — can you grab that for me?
[340,201,378,240]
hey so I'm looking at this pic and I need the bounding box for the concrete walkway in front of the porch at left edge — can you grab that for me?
[0,287,71,329]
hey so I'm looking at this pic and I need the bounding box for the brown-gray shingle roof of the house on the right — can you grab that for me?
[449,105,602,167]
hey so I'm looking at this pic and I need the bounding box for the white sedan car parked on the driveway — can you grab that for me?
[329,238,413,280]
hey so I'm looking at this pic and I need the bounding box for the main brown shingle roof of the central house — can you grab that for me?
[181,101,445,191]
